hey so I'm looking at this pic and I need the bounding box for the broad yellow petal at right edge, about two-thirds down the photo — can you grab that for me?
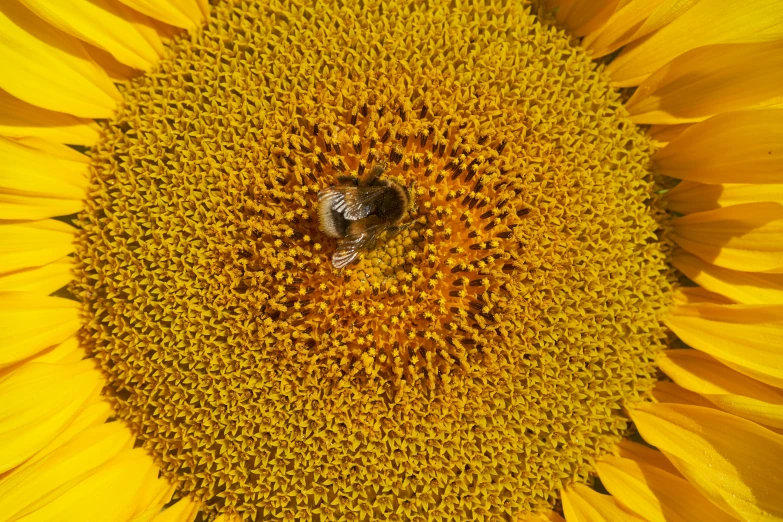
[666,298,783,388]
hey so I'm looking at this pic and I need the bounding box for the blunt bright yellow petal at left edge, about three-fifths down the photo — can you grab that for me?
[0,292,80,368]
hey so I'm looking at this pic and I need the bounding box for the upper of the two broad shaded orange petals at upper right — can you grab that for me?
[625,40,783,124]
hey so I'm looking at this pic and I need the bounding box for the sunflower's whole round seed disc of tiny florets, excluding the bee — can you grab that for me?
[75,1,669,520]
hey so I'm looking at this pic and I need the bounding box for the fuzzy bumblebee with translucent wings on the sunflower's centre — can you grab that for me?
[318,162,413,268]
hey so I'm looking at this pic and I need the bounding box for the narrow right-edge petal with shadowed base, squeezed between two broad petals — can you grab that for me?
[666,181,783,214]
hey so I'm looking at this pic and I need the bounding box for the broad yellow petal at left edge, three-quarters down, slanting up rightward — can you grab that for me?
[0,360,103,472]
